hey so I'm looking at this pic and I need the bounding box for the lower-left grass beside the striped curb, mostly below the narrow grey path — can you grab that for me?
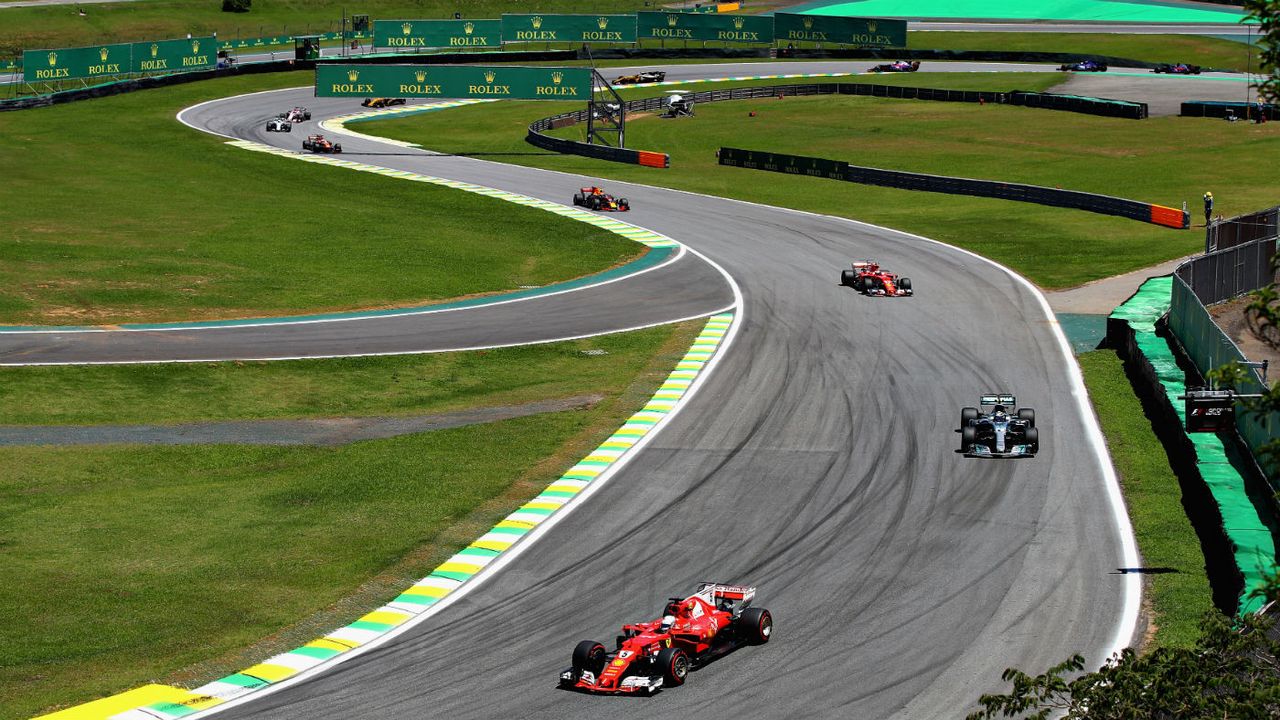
[0,322,701,720]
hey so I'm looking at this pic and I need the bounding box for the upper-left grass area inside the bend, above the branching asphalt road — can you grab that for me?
[0,69,644,324]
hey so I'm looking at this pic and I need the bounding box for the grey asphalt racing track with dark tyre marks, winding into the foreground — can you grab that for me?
[185,64,1135,719]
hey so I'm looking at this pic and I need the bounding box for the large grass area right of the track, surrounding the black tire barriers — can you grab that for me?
[362,72,1280,288]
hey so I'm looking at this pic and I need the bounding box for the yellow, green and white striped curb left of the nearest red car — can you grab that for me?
[67,313,735,720]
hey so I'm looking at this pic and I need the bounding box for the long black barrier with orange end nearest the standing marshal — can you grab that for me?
[717,147,1190,229]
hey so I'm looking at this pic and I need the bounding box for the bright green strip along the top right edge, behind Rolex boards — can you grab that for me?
[791,0,1243,24]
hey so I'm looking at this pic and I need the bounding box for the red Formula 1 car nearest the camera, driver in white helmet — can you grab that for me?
[559,583,773,694]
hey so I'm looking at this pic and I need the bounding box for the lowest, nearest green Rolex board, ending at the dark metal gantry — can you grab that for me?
[316,65,593,101]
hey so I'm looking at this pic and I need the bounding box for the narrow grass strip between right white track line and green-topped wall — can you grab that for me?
[1078,350,1213,648]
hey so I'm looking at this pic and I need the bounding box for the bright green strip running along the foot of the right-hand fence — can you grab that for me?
[1111,275,1276,614]
